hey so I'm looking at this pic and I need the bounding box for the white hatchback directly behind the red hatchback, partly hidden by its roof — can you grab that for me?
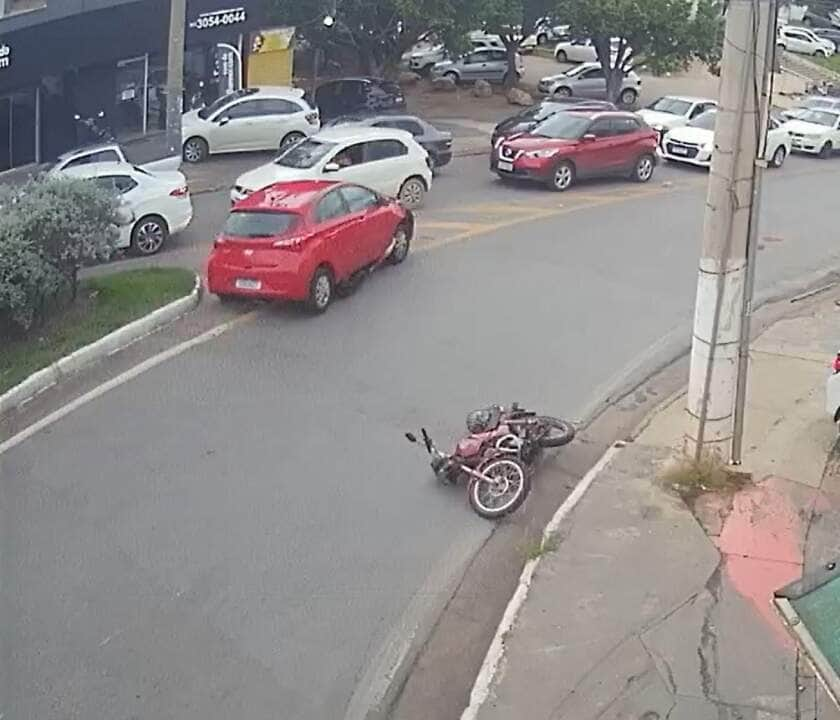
[230,125,432,209]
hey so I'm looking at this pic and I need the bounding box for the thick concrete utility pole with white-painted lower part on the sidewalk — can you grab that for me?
[685,0,776,459]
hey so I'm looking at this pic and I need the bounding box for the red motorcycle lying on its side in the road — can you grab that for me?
[405,403,575,519]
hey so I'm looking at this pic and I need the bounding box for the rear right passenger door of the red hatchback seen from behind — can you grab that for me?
[312,188,360,282]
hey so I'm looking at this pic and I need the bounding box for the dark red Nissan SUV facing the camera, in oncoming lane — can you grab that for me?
[490,110,659,191]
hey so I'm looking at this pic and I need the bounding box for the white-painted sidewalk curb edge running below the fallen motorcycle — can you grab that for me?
[461,443,624,720]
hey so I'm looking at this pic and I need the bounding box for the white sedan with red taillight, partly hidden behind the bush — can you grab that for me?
[61,162,193,255]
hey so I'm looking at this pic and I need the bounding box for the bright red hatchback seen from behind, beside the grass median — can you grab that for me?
[207,180,414,312]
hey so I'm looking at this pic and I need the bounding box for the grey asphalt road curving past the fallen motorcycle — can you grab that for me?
[0,149,840,720]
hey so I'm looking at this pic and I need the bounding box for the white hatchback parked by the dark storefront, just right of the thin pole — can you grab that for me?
[181,87,321,163]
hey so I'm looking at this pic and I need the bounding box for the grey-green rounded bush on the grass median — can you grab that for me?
[0,178,118,333]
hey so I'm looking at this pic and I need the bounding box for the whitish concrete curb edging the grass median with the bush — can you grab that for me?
[0,275,202,417]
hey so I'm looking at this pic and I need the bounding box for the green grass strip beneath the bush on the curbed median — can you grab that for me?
[0,268,195,394]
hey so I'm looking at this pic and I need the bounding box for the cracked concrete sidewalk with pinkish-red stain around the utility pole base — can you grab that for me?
[470,292,840,720]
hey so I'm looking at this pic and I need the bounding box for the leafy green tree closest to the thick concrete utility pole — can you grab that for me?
[557,0,723,102]
